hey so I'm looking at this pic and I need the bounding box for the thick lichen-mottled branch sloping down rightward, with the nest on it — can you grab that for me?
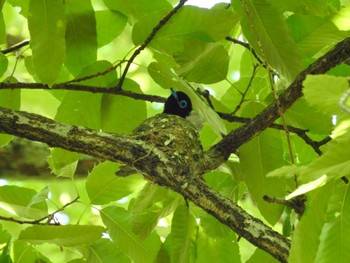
[0,108,290,262]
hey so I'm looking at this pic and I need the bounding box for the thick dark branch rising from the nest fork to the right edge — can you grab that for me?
[208,38,350,169]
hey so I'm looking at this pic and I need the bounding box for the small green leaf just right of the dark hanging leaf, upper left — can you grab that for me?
[95,10,127,47]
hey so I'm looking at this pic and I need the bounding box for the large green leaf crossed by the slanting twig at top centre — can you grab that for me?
[132,6,238,51]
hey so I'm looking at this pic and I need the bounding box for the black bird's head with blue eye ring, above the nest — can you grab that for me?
[163,88,192,118]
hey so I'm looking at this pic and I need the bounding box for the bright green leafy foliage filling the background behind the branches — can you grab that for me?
[0,0,350,263]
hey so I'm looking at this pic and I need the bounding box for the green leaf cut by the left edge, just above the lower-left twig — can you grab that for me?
[0,185,47,219]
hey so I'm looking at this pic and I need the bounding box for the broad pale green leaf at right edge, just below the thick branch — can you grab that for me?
[303,75,349,114]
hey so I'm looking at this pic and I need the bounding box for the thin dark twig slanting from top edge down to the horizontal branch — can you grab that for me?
[116,0,187,90]
